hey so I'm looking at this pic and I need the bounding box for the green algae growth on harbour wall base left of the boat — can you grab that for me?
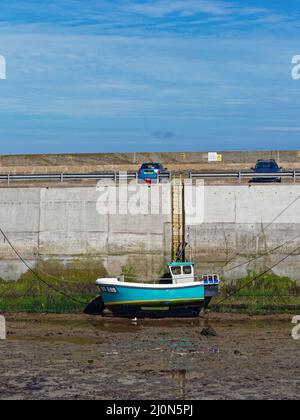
[0,260,107,313]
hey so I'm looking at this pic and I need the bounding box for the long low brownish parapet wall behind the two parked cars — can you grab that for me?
[0,150,300,174]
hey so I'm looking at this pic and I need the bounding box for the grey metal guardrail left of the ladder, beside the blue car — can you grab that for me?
[0,172,171,185]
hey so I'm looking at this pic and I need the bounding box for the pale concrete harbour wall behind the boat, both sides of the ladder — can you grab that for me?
[0,185,300,281]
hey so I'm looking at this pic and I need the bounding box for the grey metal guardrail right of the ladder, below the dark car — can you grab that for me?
[189,171,300,182]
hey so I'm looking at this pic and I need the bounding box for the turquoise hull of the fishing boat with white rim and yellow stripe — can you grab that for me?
[98,281,205,318]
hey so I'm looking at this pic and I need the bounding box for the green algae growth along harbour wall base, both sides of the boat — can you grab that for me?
[0,268,300,314]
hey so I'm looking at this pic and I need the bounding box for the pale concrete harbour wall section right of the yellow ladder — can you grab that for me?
[187,185,300,280]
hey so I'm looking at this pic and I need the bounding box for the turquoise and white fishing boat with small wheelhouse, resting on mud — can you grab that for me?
[96,262,220,318]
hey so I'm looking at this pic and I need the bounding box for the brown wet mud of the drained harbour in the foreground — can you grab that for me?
[0,314,300,400]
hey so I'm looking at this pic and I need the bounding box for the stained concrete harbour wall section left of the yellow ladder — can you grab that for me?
[0,186,171,280]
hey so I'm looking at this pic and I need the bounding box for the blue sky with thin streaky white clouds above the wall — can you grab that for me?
[0,0,300,154]
